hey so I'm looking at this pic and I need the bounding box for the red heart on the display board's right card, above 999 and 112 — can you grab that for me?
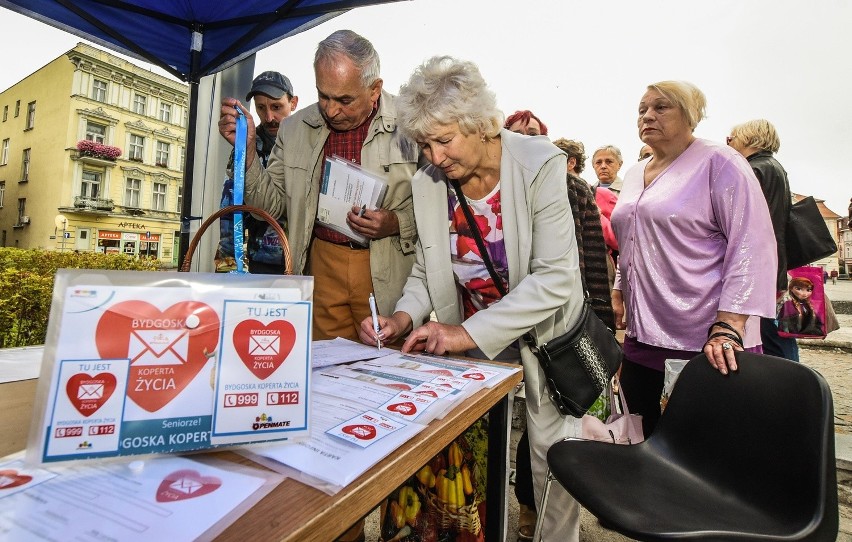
[234,320,296,380]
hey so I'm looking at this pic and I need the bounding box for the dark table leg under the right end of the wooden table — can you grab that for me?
[485,393,514,542]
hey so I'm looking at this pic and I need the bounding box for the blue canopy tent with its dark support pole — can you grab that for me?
[0,0,396,261]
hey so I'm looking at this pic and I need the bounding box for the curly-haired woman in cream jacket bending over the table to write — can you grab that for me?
[360,57,583,541]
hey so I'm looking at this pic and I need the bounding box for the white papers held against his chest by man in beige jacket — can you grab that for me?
[317,156,387,246]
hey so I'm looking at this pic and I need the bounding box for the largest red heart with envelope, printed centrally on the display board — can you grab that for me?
[95,301,219,412]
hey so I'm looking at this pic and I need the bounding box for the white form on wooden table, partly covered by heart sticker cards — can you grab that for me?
[240,393,425,492]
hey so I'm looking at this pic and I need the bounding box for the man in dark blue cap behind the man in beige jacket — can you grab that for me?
[216,71,299,274]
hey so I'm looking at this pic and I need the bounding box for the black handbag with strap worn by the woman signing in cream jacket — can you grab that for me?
[450,180,623,418]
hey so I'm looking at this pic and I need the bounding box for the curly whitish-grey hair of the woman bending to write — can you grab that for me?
[397,56,503,141]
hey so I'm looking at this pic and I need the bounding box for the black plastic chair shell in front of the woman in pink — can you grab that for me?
[547,352,838,542]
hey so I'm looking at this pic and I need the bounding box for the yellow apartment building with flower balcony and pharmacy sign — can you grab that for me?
[0,43,189,267]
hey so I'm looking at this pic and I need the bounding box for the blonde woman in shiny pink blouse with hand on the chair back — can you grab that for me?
[612,81,777,436]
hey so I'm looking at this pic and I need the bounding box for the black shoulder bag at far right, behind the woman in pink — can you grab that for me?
[784,196,837,269]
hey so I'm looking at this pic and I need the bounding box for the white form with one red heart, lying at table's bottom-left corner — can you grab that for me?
[0,457,280,542]
